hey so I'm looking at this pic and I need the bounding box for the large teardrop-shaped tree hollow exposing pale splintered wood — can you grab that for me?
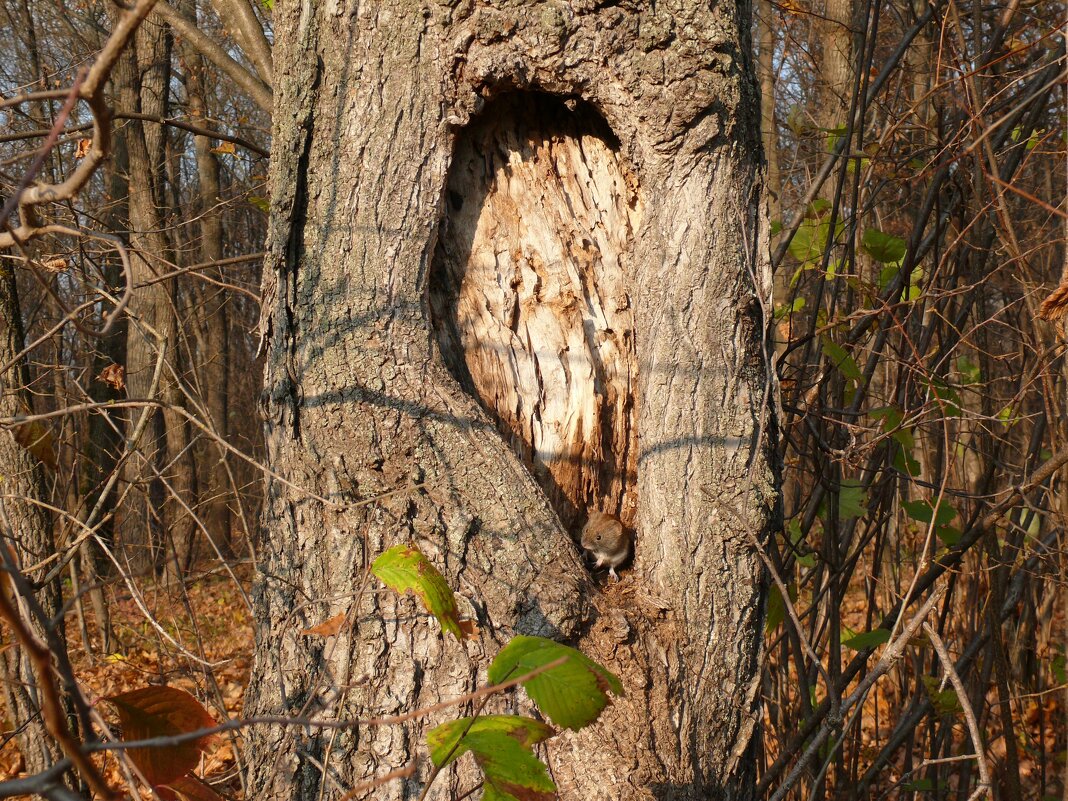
[429,93,642,528]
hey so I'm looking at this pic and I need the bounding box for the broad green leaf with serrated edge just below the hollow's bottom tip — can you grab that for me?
[488,634,623,732]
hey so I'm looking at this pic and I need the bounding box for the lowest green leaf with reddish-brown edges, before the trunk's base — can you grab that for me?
[426,714,556,801]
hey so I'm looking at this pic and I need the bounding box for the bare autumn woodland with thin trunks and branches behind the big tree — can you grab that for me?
[0,0,1068,801]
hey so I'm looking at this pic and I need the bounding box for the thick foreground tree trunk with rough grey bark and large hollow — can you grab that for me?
[246,0,775,799]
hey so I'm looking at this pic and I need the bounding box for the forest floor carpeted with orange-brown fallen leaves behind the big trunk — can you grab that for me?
[0,566,1065,801]
